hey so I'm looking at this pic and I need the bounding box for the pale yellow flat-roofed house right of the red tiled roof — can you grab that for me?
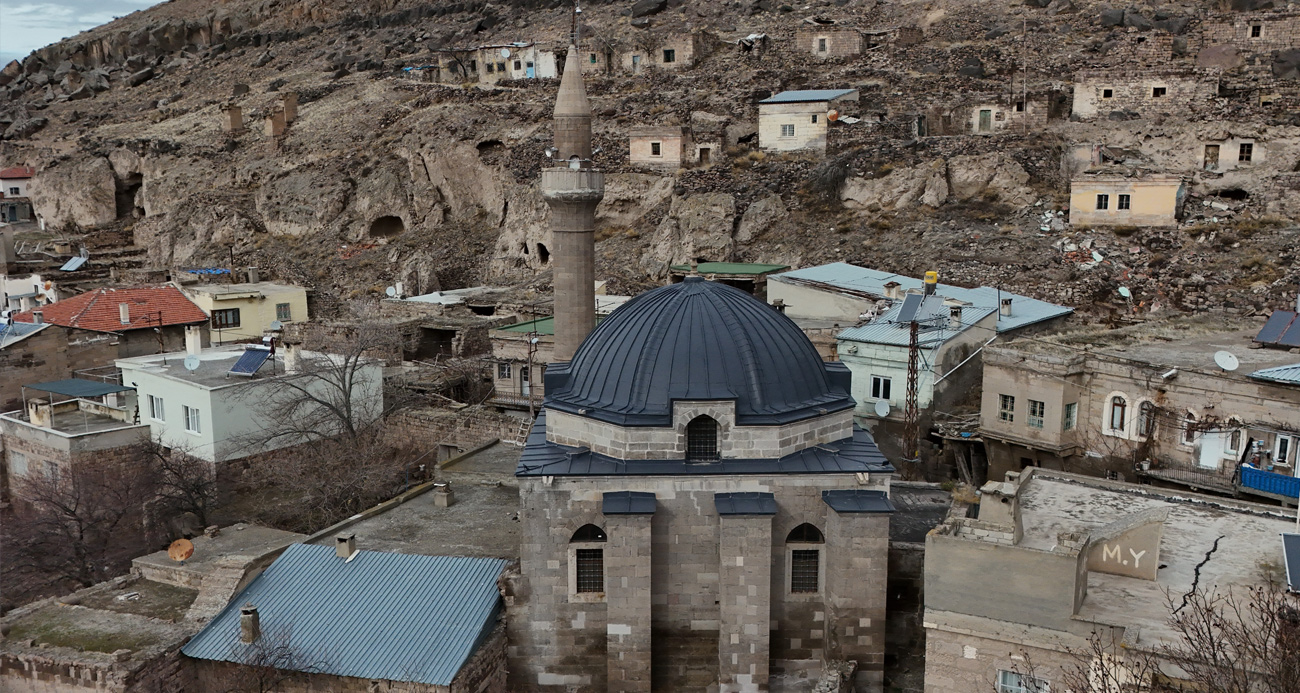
[181,282,307,345]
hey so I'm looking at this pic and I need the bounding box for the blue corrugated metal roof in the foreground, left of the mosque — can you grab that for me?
[182,543,506,685]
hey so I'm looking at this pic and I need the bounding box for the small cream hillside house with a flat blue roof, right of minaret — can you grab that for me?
[758,88,858,153]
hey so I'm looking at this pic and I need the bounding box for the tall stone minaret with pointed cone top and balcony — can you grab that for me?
[542,46,605,363]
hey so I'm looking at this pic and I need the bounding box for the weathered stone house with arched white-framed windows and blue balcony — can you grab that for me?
[980,327,1300,491]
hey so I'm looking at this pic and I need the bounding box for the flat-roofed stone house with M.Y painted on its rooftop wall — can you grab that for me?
[924,469,1295,693]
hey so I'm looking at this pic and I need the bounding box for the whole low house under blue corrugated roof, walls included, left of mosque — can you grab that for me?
[181,546,506,693]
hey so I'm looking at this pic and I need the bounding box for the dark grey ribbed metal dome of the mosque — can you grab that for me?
[546,277,854,426]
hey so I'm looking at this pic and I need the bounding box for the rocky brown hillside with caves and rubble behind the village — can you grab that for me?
[0,0,1300,312]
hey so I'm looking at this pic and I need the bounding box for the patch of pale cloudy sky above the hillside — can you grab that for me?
[0,0,157,66]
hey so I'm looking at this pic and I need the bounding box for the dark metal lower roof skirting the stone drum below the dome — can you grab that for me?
[515,410,894,477]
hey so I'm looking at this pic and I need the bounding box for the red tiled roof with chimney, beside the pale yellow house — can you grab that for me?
[14,286,208,332]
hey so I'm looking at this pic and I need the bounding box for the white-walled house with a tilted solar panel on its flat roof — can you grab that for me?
[117,338,384,463]
